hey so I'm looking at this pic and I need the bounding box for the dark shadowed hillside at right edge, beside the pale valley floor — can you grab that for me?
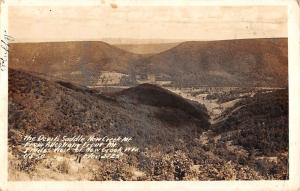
[215,89,289,155]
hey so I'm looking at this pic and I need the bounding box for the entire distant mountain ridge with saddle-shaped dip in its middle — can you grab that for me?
[9,38,288,87]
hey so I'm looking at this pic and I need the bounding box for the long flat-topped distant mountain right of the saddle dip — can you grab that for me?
[145,39,288,86]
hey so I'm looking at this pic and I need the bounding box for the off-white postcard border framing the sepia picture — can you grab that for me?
[0,0,300,191]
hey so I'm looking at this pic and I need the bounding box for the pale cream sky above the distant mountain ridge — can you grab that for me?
[8,4,287,44]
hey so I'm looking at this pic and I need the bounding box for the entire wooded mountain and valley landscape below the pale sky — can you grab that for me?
[8,38,289,181]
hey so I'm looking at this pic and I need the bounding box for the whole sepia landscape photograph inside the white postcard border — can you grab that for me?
[1,0,298,190]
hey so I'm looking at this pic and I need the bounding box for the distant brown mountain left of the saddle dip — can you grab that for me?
[9,41,139,85]
